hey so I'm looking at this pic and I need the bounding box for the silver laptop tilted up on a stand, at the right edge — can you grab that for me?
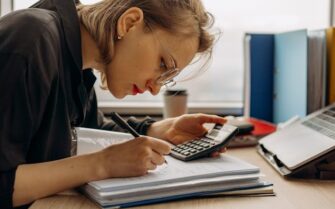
[258,103,335,175]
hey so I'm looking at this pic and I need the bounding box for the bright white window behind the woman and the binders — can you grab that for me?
[2,0,331,114]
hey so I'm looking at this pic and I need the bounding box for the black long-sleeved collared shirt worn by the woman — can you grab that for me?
[0,0,153,209]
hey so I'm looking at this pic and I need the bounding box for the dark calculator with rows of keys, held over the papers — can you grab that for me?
[170,124,238,161]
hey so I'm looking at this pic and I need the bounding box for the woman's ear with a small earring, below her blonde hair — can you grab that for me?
[116,7,144,39]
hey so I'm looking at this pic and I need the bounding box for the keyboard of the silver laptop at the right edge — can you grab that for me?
[302,107,335,139]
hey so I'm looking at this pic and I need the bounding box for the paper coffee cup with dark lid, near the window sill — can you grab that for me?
[163,89,187,118]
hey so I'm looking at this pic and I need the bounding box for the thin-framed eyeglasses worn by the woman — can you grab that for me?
[155,56,180,88]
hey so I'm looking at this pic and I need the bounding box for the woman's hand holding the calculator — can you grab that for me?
[148,113,226,156]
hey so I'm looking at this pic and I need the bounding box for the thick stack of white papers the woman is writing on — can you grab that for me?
[77,128,272,208]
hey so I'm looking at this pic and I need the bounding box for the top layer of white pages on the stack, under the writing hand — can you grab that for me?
[89,156,259,192]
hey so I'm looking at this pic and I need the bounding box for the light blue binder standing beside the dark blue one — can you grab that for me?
[273,30,308,123]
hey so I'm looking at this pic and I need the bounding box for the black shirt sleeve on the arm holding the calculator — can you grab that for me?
[81,90,156,135]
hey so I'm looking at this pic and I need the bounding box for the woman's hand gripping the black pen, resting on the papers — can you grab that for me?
[96,136,171,179]
